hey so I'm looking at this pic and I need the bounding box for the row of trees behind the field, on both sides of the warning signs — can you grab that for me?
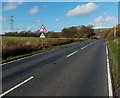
[3,25,95,38]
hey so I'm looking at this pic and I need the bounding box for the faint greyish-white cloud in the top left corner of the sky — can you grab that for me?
[2,1,23,12]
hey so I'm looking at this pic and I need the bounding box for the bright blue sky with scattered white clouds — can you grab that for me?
[0,2,118,33]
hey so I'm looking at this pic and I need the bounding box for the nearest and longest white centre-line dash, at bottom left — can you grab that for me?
[0,76,34,97]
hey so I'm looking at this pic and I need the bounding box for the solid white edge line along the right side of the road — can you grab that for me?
[106,42,113,98]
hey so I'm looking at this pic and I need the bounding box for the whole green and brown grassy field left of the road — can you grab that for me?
[2,36,81,62]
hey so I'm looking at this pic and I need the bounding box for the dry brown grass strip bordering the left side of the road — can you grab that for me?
[2,37,80,59]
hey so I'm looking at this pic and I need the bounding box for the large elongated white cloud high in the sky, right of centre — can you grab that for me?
[66,3,98,17]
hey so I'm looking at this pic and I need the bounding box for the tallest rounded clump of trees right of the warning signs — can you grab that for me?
[61,25,95,38]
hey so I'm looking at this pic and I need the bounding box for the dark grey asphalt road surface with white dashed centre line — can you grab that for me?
[1,40,108,96]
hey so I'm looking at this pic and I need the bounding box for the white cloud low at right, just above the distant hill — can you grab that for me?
[89,16,117,26]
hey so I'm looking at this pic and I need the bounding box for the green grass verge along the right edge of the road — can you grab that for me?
[109,40,120,95]
